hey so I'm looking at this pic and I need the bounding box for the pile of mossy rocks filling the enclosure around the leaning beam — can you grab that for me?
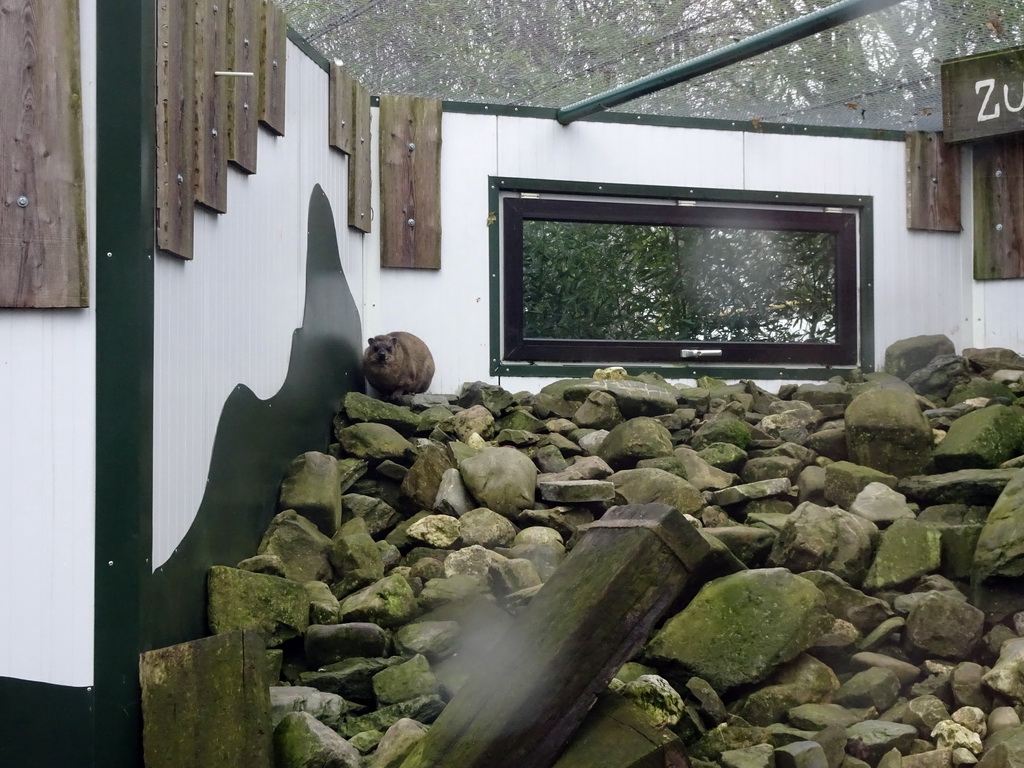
[201,337,1024,768]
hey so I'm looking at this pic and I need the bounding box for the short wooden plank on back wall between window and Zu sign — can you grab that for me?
[906,131,963,232]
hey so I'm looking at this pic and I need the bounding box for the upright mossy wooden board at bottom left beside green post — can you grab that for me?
[139,631,272,768]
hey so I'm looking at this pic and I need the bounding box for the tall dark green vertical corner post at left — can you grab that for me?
[95,0,156,768]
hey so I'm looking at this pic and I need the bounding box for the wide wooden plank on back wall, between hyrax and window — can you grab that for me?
[380,96,441,269]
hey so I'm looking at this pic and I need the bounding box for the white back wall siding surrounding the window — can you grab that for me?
[376,113,983,392]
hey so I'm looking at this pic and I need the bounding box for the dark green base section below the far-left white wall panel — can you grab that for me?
[0,677,93,768]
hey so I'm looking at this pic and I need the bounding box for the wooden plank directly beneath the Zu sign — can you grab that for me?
[974,135,1024,280]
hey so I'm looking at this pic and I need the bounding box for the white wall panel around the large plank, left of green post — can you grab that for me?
[0,0,96,687]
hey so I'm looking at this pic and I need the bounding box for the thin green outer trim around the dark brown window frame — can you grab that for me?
[487,176,874,381]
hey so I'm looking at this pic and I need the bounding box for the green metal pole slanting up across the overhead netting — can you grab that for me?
[555,0,902,125]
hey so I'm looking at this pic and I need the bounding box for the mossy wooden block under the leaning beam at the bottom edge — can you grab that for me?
[553,692,690,768]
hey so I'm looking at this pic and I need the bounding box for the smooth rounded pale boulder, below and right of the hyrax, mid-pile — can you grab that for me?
[459,446,537,519]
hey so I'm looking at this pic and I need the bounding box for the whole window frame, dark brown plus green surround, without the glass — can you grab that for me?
[490,178,872,378]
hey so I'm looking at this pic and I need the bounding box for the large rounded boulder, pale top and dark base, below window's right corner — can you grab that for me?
[846,388,933,477]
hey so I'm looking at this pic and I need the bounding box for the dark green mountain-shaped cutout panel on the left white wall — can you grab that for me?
[147,185,364,649]
